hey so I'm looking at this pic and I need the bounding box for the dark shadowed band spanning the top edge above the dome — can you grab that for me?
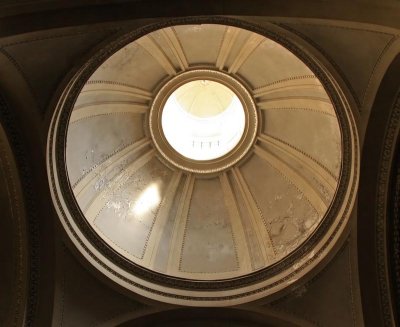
[0,0,400,35]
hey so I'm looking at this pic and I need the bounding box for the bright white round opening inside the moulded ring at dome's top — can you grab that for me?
[161,80,245,160]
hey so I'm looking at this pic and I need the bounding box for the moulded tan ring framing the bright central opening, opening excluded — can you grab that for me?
[149,69,258,174]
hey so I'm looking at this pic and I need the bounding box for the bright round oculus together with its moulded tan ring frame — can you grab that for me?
[149,68,259,175]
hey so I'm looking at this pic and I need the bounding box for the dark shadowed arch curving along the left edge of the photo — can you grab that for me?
[0,107,29,326]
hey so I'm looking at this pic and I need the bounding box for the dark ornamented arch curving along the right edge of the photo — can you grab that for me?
[357,55,400,326]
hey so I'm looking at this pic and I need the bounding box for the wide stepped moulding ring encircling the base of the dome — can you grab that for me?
[47,17,359,306]
